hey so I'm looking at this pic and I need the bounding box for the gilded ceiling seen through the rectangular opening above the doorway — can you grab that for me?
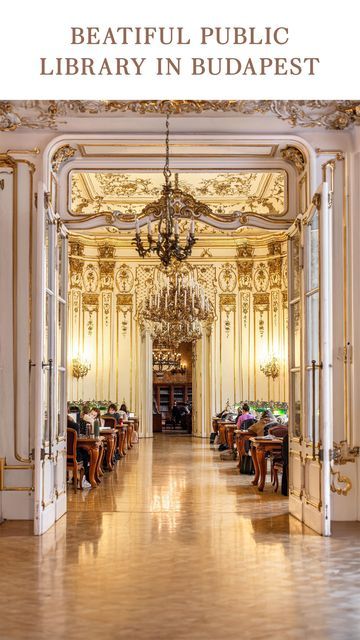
[70,170,287,216]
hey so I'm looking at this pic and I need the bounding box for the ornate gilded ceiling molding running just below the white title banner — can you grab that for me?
[0,100,360,131]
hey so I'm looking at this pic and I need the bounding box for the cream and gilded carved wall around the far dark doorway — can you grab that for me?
[68,239,287,411]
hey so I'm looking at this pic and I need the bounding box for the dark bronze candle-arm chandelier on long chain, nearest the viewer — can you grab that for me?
[134,114,211,267]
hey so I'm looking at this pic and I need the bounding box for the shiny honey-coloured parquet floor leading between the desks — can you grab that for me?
[0,434,360,640]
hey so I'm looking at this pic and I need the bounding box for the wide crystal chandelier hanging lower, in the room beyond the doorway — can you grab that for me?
[142,271,212,324]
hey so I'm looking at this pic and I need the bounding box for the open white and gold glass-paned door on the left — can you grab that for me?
[34,184,67,535]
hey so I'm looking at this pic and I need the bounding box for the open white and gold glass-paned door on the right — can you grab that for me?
[288,182,332,536]
